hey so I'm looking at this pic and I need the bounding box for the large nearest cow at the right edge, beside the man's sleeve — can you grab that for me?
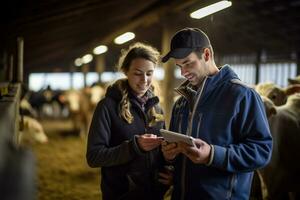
[254,93,300,200]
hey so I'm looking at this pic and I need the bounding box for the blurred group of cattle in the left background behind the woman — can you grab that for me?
[19,85,105,143]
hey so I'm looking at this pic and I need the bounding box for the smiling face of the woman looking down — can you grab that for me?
[125,58,155,97]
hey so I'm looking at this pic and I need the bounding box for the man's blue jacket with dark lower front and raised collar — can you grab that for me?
[170,66,272,200]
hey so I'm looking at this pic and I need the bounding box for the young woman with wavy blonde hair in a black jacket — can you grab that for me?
[86,43,170,200]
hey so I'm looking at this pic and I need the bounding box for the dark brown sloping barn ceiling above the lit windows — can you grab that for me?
[0,0,300,73]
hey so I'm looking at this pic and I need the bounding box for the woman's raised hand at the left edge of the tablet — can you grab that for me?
[137,134,163,151]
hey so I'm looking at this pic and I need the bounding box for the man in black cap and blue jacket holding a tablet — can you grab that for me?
[162,28,272,200]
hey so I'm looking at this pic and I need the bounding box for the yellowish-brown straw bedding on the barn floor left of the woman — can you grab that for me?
[25,120,101,200]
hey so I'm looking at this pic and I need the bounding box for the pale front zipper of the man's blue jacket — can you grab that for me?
[180,77,207,200]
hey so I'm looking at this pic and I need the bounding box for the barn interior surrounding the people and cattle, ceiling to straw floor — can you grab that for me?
[0,0,300,200]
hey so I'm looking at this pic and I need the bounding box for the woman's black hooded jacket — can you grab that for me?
[86,80,165,200]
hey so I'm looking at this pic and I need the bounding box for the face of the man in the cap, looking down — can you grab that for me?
[175,52,209,85]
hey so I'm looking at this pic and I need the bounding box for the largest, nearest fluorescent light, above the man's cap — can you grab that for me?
[190,1,232,19]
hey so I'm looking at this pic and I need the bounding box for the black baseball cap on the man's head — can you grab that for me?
[162,28,210,63]
